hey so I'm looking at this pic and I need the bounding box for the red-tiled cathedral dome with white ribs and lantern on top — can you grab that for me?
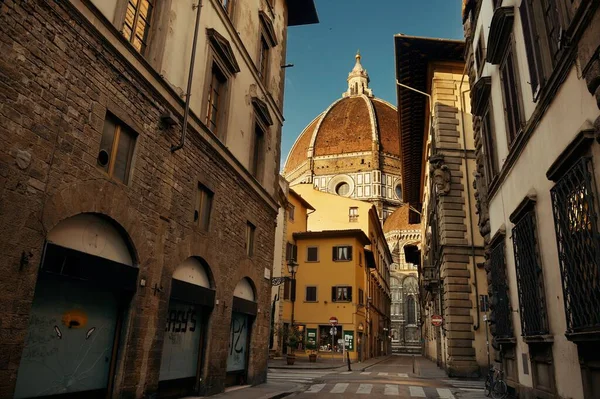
[283,54,400,175]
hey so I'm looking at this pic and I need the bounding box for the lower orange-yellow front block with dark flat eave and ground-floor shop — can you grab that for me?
[284,229,370,360]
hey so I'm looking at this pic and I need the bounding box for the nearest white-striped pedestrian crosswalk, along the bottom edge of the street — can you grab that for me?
[304,382,455,399]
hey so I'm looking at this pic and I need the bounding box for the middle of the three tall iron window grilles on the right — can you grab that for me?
[512,209,548,337]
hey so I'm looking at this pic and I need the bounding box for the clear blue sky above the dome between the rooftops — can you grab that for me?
[281,0,463,168]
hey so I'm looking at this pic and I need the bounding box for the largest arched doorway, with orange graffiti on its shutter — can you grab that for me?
[14,213,138,398]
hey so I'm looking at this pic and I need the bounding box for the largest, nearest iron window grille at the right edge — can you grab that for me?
[550,157,600,333]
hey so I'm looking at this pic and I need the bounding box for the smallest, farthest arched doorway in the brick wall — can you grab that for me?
[226,278,258,386]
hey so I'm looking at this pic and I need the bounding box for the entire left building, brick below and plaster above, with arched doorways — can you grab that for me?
[0,0,316,398]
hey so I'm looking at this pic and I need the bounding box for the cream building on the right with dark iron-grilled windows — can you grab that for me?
[463,0,600,399]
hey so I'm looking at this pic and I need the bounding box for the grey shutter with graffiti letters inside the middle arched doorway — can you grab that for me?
[159,299,201,381]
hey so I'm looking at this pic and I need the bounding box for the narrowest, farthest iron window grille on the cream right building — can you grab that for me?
[490,241,513,338]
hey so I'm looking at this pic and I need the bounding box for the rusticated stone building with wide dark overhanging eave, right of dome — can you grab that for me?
[395,35,488,377]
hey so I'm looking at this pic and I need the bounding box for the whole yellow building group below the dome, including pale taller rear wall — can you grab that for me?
[276,184,392,360]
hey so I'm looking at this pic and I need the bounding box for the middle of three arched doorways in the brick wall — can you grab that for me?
[158,257,215,397]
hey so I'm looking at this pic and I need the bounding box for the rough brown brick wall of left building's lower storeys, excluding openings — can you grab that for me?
[0,0,276,397]
